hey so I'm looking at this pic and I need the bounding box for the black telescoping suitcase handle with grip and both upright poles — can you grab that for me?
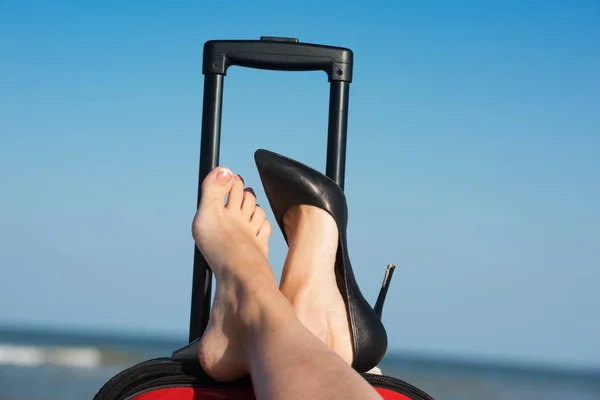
[189,37,353,342]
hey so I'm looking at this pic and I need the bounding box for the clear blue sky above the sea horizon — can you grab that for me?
[0,0,600,367]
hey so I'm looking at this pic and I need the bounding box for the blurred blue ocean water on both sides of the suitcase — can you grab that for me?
[0,329,600,400]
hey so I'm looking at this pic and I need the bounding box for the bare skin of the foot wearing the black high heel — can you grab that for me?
[280,205,353,364]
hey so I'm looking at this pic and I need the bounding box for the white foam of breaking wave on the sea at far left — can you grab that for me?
[0,343,102,368]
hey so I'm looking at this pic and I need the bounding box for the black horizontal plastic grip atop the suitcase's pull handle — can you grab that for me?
[202,36,354,82]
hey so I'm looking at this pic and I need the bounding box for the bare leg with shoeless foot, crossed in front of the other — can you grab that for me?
[193,170,380,400]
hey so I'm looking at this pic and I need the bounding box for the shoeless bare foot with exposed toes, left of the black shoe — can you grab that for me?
[192,168,277,381]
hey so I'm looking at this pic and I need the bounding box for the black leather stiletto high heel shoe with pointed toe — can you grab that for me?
[254,149,393,372]
